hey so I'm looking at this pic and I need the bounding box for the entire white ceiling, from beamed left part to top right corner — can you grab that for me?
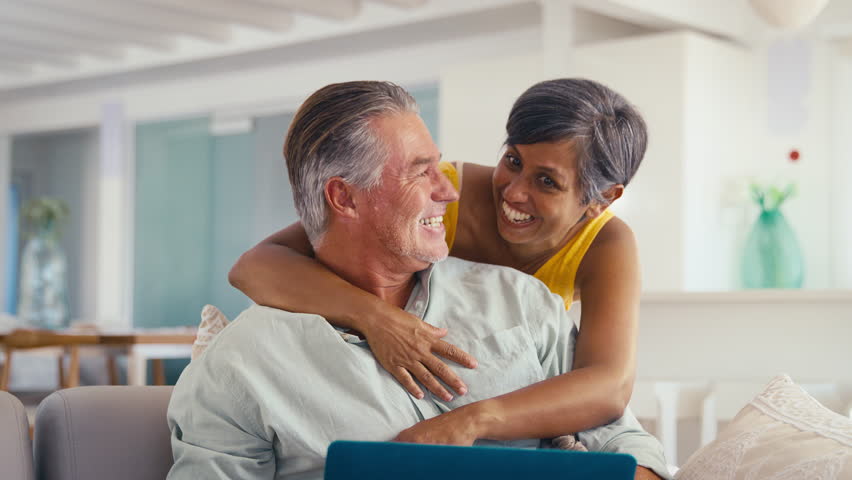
[0,0,852,91]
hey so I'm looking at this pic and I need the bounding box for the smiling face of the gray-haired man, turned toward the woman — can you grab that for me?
[360,113,458,271]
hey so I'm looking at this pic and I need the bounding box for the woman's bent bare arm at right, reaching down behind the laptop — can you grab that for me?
[398,216,640,444]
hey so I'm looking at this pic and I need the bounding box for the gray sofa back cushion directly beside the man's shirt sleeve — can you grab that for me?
[33,386,172,480]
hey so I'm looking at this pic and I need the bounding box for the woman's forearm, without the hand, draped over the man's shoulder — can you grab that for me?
[228,242,390,330]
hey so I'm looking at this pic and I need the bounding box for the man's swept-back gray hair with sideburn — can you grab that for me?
[284,81,418,248]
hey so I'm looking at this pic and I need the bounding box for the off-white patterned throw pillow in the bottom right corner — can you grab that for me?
[675,375,852,480]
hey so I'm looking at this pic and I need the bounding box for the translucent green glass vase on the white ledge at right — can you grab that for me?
[741,208,805,288]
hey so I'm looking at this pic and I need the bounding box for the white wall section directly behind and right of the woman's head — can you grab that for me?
[575,33,687,290]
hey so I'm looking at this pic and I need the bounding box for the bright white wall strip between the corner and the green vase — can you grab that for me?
[680,35,762,290]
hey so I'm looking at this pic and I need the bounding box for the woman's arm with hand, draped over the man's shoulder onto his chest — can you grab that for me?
[228,223,476,398]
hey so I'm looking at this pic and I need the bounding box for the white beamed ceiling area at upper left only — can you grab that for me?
[0,0,472,89]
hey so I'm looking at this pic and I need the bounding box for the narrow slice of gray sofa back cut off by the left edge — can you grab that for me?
[0,391,33,480]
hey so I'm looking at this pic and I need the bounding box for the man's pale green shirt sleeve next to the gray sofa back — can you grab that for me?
[168,355,276,480]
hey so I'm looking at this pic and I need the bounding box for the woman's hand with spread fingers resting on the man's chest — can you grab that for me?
[360,309,476,401]
